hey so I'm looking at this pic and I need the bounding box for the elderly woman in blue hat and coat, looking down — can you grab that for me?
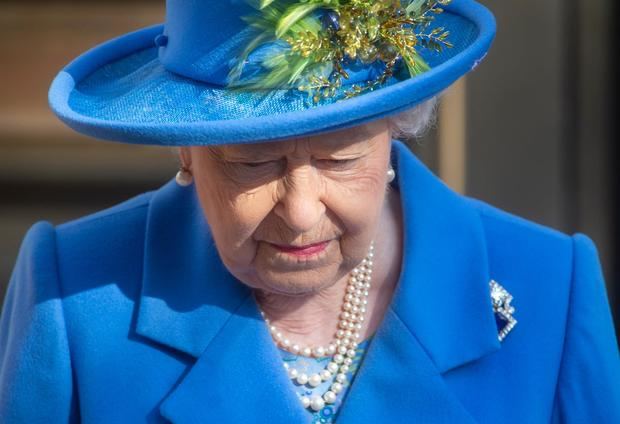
[0,0,620,423]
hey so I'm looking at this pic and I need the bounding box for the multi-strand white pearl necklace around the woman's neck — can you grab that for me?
[261,243,374,411]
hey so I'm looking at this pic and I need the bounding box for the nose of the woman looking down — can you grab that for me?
[274,165,325,233]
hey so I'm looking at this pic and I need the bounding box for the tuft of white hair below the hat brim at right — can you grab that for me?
[384,96,439,140]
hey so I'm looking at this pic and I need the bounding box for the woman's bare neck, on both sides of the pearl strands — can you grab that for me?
[255,190,402,345]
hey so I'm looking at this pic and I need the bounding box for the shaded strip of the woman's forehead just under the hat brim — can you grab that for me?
[221,121,387,156]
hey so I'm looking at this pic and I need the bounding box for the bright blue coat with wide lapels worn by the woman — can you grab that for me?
[0,142,620,424]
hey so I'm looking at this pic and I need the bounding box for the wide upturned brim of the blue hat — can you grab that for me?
[49,0,495,146]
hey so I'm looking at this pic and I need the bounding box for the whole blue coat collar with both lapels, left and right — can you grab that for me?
[136,141,500,423]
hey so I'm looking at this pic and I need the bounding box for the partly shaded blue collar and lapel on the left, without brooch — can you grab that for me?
[136,176,307,424]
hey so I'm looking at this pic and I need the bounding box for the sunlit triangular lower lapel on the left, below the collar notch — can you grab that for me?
[160,296,308,424]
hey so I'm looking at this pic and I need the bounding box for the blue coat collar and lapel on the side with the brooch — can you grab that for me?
[338,143,500,423]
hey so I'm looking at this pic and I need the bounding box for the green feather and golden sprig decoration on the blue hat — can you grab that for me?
[228,0,452,102]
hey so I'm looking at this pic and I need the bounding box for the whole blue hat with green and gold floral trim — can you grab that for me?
[49,0,495,146]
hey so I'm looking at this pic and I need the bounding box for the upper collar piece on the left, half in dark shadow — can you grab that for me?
[136,180,250,357]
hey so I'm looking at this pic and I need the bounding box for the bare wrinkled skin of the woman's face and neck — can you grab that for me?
[180,120,401,343]
